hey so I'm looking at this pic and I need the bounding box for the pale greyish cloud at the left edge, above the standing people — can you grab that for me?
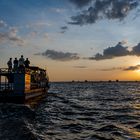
[0,28,24,46]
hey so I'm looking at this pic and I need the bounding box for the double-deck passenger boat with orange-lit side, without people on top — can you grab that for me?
[0,66,49,104]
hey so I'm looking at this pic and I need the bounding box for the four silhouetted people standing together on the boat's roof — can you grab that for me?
[7,55,30,71]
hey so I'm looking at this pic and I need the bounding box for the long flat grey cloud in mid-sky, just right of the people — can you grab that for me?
[36,50,80,61]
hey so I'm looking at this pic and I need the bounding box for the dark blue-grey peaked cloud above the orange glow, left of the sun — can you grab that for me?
[89,42,130,60]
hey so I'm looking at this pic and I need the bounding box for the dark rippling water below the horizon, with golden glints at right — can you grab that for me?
[0,82,140,140]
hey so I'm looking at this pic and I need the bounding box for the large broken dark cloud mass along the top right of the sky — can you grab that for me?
[69,0,139,25]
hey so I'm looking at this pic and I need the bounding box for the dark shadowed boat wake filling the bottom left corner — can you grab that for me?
[0,104,41,140]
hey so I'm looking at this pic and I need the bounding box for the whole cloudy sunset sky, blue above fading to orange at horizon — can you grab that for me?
[0,0,140,81]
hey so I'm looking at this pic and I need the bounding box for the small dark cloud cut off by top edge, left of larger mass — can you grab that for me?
[70,0,92,8]
